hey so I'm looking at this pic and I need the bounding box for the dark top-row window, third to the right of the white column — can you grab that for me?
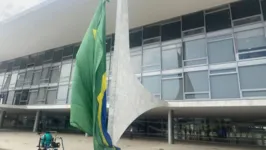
[162,22,181,41]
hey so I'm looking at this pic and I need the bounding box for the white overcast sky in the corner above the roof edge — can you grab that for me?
[0,0,44,22]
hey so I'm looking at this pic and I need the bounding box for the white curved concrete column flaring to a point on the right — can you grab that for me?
[108,0,167,144]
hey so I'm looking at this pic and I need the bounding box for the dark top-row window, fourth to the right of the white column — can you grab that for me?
[182,11,204,31]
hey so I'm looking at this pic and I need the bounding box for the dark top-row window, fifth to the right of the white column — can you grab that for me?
[206,10,231,32]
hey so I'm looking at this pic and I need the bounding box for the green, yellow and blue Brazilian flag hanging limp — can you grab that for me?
[70,0,118,150]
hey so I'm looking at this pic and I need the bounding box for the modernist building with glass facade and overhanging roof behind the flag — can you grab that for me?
[0,0,266,145]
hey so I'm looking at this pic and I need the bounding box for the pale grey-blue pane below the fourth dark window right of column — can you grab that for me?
[184,39,206,60]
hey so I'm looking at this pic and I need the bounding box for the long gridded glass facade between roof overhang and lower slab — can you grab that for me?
[0,0,266,105]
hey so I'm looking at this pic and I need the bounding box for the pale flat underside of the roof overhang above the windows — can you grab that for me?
[0,0,236,61]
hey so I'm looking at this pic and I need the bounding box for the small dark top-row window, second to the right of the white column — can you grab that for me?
[143,25,161,39]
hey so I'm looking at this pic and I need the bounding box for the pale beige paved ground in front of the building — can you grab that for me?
[0,132,265,150]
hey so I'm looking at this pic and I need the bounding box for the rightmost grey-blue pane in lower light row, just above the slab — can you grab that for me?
[239,65,266,89]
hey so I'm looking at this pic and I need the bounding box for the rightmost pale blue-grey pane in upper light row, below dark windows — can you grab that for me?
[236,28,266,52]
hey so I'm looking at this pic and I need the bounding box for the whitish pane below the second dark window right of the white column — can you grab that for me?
[143,47,161,71]
